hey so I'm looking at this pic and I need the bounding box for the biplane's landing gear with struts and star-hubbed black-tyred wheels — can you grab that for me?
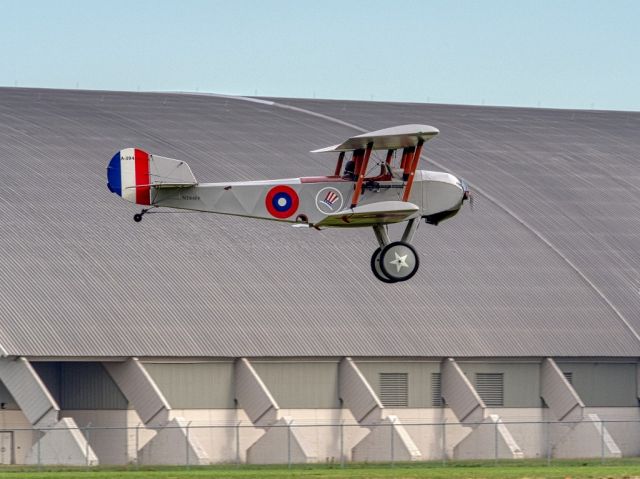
[371,219,420,283]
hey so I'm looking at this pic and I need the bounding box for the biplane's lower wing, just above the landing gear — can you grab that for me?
[314,201,420,228]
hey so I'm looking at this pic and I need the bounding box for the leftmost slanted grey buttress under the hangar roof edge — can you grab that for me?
[0,358,59,424]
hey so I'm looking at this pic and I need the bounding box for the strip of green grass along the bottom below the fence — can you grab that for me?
[0,459,640,479]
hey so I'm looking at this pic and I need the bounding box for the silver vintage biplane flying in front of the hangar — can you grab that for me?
[107,125,470,283]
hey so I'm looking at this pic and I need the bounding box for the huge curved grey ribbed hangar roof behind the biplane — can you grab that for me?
[0,88,640,357]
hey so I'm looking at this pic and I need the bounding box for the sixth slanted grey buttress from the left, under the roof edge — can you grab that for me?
[540,358,584,420]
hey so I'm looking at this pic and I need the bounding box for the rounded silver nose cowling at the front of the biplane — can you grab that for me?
[423,171,469,225]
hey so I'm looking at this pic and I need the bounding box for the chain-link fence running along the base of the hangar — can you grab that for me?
[5,415,640,467]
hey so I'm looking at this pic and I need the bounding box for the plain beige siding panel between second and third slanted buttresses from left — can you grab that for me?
[144,361,235,409]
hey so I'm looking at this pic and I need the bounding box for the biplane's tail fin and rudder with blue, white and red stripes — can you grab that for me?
[107,148,198,205]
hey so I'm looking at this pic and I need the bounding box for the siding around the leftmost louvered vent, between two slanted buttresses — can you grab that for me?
[357,360,440,408]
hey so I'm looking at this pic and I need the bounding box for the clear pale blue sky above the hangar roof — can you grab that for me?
[0,0,640,110]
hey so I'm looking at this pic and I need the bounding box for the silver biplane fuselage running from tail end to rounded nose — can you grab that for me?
[152,170,465,227]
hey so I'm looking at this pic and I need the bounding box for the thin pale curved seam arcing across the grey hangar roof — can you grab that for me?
[266,97,640,343]
